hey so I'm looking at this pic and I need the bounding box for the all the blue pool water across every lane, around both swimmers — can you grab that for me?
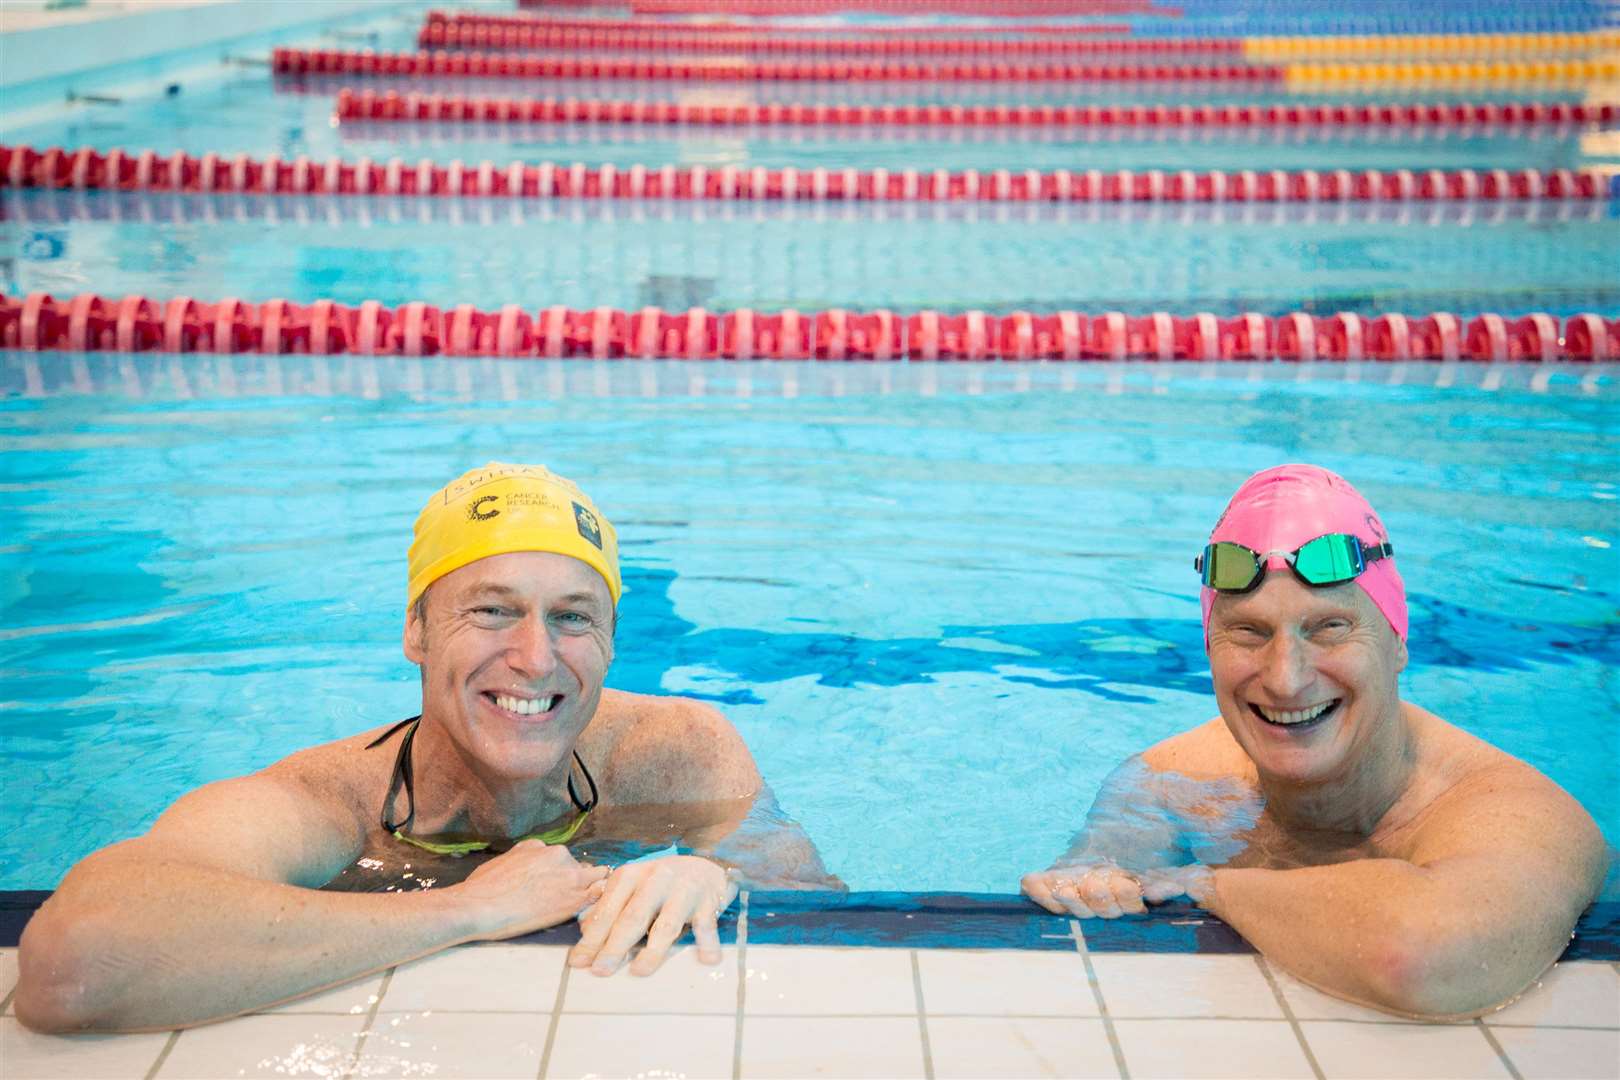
[0,5,1620,892]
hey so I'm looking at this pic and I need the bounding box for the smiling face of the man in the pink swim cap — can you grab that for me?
[1209,560,1406,784]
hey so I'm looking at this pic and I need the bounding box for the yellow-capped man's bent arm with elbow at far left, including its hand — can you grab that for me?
[16,767,604,1031]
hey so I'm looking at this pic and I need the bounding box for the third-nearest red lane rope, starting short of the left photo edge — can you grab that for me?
[322,89,1620,130]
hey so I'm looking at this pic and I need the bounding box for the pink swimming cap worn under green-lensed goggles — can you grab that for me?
[1202,465,1406,648]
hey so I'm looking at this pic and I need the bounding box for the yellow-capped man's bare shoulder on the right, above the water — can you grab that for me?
[582,690,760,801]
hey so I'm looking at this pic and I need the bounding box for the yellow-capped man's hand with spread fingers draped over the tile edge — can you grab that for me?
[569,855,737,975]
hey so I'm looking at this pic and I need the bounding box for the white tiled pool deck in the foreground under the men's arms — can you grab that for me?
[0,921,1620,1080]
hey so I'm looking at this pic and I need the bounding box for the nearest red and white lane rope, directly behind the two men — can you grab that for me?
[0,293,1620,363]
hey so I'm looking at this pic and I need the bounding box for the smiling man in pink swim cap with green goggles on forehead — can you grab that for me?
[1022,465,1609,1017]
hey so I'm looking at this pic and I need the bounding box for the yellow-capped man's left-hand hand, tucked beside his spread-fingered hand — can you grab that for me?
[447,840,608,941]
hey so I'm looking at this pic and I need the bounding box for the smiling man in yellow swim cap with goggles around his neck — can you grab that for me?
[16,463,839,1031]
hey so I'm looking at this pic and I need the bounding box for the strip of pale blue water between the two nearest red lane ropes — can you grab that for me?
[0,191,1620,316]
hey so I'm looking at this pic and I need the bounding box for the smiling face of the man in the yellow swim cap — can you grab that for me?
[405,551,614,779]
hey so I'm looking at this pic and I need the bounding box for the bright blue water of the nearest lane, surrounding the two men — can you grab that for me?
[0,355,1620,892]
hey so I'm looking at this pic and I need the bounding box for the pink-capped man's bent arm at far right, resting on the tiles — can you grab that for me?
[1191,763,1607,1017]
